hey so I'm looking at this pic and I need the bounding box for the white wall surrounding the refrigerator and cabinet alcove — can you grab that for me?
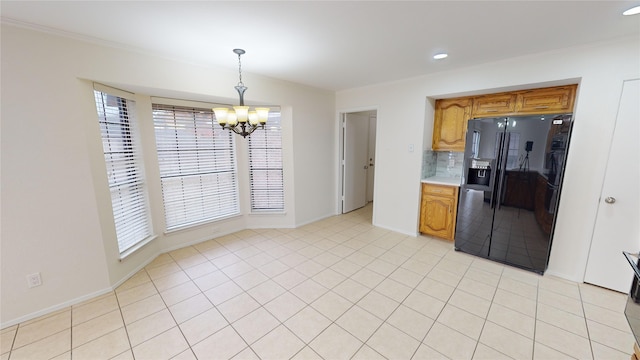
[336,37,640,281]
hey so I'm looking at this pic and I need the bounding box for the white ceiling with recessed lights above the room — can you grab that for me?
[0,0,640,90]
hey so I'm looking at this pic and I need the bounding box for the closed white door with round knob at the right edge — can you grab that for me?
[584,79,640,292]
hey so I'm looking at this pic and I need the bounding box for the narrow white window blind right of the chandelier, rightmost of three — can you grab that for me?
[247,107,284,212]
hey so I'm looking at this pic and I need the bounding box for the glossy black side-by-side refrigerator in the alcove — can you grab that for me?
[455,114,572,274]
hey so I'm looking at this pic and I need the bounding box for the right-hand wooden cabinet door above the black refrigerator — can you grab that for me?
[516,85,577,114]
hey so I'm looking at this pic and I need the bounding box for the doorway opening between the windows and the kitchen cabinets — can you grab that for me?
[340,110,377,214]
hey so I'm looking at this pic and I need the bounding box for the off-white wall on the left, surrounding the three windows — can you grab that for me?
[0,24,337,327]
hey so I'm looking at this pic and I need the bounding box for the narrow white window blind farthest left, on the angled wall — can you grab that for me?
[94,90,151,254]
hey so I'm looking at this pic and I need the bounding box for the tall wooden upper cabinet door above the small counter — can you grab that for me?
[432,98,472,151]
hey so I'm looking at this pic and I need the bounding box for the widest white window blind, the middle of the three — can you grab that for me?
[153,104,240,230]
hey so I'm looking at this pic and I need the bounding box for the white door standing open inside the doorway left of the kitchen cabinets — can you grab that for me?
[342,113,369,213]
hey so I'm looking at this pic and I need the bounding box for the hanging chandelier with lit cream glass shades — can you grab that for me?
[213,49,269,138]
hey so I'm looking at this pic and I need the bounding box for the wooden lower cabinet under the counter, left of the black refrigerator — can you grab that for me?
[420,183,458,240]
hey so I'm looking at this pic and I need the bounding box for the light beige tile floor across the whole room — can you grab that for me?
[0,205,634,360]
